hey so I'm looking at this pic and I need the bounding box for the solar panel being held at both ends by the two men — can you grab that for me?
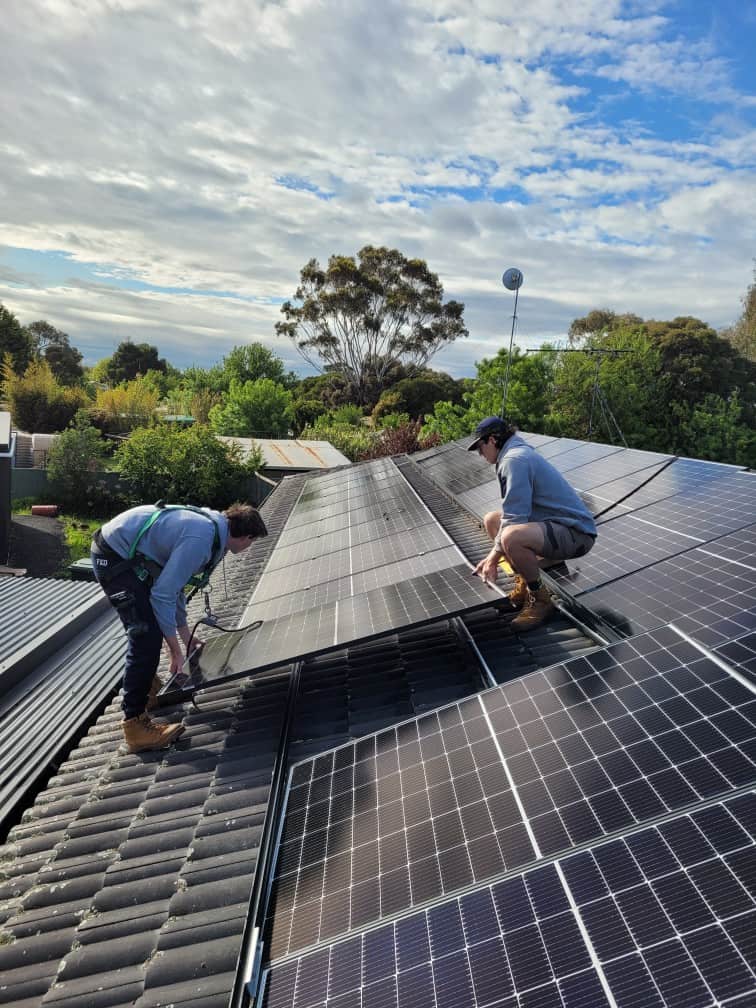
[162,564,502,692]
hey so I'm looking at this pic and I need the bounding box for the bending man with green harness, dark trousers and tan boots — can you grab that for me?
[92,503,268,752]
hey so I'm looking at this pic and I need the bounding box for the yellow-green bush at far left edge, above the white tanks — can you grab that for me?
[3,360,90,433]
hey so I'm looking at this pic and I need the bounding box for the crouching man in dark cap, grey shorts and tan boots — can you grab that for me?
[468,416,596,631]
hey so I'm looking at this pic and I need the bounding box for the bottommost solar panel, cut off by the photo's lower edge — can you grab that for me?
[262,793,756,1008]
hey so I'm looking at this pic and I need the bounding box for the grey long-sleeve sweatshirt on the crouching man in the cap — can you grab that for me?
[496,434,596,535]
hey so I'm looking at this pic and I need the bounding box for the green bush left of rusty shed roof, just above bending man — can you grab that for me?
[116,423,261,507]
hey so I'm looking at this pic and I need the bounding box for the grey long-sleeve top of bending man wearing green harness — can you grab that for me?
[102,504,229,637]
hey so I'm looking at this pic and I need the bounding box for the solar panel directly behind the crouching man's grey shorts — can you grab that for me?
[552,514,701,595]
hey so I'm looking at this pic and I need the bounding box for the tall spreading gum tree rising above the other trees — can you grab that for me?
[275,245,468,405]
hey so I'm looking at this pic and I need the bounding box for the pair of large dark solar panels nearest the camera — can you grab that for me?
[263,628,756,1008]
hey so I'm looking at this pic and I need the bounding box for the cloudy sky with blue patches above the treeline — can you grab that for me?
[0,0,756,377]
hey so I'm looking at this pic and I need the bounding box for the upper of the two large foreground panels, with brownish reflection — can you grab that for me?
[270,629,756,958]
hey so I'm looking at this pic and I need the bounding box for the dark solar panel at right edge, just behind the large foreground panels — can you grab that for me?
[580,552,756,647]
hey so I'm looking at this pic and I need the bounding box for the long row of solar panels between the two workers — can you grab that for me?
[165,455,512,691]
